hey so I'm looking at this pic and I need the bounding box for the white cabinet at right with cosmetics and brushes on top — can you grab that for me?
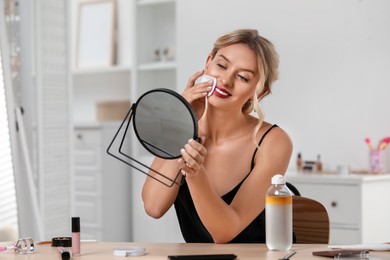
[286,171,390,244]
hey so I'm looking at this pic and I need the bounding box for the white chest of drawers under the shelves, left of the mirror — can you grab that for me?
[72,122,132,241]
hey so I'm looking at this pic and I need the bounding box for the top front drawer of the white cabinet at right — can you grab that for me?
[293,183,361,227]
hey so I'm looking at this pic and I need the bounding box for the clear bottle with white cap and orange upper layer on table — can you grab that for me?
[265,174,293,251]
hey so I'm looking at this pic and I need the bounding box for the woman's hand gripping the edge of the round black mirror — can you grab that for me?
[178,137,207,176]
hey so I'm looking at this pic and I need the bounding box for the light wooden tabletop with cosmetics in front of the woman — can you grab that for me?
[0,242,390,260]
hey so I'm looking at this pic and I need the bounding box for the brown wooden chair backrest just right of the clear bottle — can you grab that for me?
[293,196,329,244]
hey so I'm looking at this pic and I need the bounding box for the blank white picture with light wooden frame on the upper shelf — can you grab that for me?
[76,0,116,69]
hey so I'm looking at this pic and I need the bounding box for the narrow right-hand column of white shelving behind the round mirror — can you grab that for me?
[127,0,183,242]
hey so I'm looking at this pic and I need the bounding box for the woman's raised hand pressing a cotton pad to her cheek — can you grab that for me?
[182,70,213,119]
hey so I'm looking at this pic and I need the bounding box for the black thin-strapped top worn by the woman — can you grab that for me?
[174,125,277,243]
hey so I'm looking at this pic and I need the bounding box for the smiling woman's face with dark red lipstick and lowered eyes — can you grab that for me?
[205,44,259,109]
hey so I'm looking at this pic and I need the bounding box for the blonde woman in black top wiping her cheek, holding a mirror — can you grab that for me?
[142,29,292,243]
